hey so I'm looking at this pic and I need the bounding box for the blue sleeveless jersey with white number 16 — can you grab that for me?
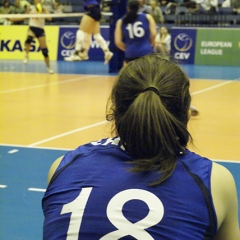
[122,13,153,59]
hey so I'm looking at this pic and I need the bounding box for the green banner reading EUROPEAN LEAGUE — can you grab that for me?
[195,28,240,66]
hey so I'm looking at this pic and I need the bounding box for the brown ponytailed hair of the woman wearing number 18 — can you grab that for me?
[107,54,191,185]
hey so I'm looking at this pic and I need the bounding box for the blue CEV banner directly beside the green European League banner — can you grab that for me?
[171,28,197,64]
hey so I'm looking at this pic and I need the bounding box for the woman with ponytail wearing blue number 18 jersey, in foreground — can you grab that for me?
[42,54,240,240]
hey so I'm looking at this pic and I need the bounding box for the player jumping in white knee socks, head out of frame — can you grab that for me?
[64,0,113,64]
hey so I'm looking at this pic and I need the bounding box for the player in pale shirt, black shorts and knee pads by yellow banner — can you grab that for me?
[23,0,53,74]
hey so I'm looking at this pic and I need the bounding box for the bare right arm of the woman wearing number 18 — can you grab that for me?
[211,163,240,240]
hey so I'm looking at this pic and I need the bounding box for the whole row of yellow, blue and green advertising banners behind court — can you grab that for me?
[0,26,240,66]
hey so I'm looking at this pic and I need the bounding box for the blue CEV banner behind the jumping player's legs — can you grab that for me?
[57,26,110,61]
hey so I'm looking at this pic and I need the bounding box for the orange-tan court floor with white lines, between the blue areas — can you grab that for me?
[0,63,240,161]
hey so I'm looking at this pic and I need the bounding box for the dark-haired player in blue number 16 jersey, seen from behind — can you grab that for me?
[114,0,156,65]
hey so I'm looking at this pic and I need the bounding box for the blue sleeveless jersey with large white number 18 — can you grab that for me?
[42,138,217,240]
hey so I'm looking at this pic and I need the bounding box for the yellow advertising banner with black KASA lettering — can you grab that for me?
[0,25,59,61]
